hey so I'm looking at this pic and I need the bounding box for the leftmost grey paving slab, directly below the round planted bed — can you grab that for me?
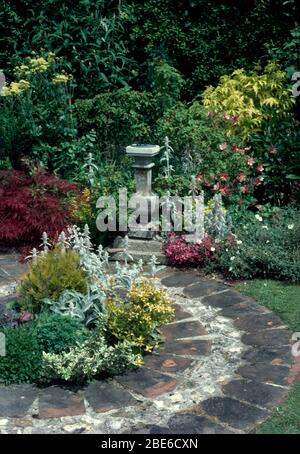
[0,385,38,418]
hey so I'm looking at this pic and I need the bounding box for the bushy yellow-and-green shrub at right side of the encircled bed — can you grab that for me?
[106,280,174,351]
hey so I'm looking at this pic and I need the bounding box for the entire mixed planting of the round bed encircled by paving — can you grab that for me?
[0,226,174,383]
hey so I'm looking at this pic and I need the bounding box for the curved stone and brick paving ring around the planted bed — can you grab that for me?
[0,257,292,434]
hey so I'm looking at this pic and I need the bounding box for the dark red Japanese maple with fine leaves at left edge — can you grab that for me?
[0,169,76,246]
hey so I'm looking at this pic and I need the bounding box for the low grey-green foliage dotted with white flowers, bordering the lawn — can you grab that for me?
[213,208,300,282]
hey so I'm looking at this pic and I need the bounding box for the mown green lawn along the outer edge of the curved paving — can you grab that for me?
[237,280,300,434]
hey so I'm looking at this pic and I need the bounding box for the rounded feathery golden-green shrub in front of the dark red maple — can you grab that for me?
[18,247,87,312]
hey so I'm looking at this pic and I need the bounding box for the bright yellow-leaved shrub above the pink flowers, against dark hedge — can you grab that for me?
[202,62,295,139]
